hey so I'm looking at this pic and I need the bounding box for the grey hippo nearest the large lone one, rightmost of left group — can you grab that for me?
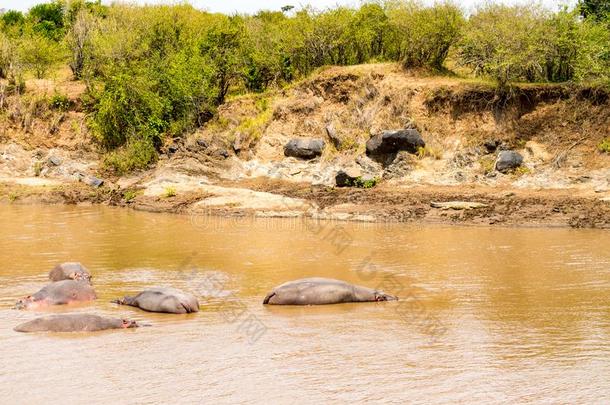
[112,288,199,314]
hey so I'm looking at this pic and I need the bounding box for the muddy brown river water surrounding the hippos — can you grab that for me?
[0,206,610,404]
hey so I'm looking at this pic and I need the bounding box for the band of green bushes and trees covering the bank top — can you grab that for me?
[0,0,610,172]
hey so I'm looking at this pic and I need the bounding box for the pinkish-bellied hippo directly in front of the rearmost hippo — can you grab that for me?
[15,280,97,309]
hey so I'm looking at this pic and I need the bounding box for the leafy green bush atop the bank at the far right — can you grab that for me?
[457,4,610,85]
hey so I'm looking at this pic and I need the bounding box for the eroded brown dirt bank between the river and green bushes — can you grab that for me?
[0,65,610,228]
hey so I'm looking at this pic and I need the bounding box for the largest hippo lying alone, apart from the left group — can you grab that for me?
[263,277,398,305]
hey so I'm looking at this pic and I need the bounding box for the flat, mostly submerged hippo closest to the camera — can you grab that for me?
[15,314,140,333]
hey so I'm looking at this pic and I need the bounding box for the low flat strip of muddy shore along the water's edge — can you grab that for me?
[0,180,610,229]
